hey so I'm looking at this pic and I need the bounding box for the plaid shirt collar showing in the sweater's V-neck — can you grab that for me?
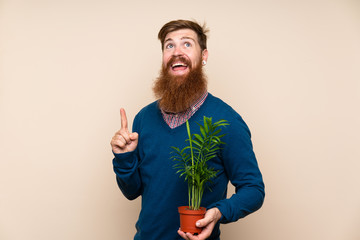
[161,91,208,128]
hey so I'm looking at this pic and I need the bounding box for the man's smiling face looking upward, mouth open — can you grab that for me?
[163,29,208,77]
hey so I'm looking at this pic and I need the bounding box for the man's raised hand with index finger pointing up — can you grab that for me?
[110,108,139,154]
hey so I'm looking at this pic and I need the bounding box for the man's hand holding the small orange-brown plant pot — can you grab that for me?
[178,208,221,240]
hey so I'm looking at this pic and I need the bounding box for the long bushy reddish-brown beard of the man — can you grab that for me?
[153,56,207,113]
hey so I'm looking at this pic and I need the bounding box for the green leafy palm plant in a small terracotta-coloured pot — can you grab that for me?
[171,116,229,234]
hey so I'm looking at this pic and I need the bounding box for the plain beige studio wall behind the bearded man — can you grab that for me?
[0,0,360,240]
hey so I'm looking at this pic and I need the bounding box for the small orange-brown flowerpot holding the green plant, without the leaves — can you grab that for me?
[178,206,206,234]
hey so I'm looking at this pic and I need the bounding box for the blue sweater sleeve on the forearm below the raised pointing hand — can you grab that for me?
[113,113,142,200]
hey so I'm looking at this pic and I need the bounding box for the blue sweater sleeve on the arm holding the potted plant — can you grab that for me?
[211,115,265,223]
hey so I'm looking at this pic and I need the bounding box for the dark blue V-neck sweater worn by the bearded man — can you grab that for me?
[113,94,265,240]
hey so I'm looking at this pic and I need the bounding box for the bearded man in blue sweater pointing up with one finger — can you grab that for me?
[111,20,265,240]
